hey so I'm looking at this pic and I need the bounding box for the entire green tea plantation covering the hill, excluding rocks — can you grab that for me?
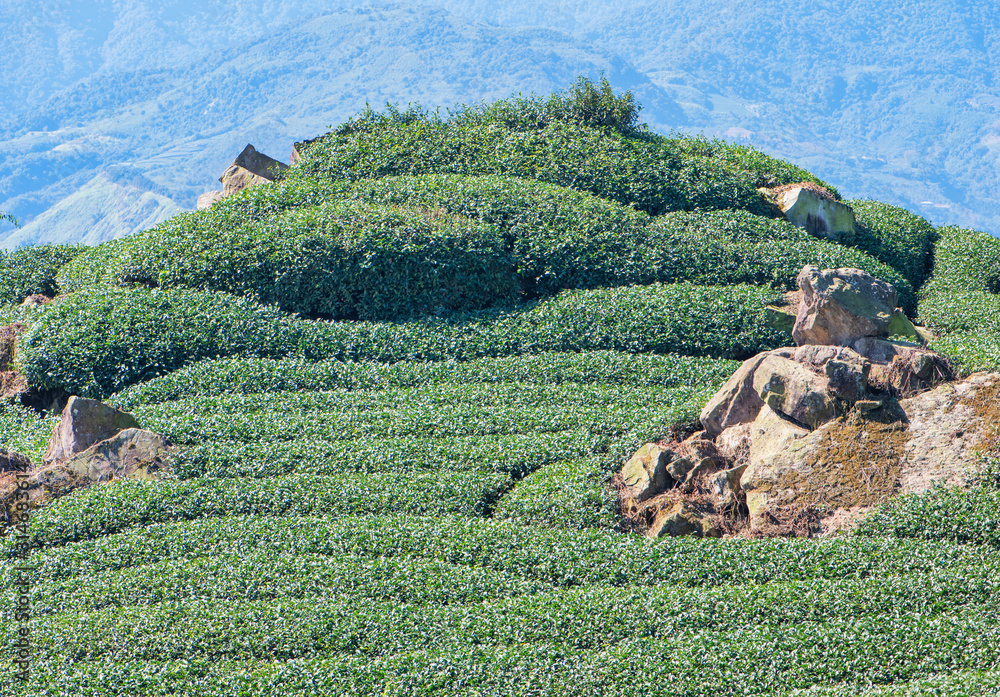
[0,82,1000,697]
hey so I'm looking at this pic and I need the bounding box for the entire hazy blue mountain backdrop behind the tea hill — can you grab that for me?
[0,0,1000,246]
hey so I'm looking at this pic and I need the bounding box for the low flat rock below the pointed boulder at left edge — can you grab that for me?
[0,428,169,508]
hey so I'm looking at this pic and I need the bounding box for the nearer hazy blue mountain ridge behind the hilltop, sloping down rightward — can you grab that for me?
[0,3,683,246]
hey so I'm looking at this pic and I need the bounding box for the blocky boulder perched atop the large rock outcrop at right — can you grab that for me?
[792,266,898,346]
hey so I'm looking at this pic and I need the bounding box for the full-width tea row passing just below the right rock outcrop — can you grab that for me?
[7,512,997,587]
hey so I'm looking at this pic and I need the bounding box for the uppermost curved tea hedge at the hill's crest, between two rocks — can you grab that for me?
[289,117,771,215]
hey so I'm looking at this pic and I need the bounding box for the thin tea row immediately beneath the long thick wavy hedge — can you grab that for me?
[111,351,739,410]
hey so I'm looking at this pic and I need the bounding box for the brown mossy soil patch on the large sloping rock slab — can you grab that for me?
[792,402,909,509]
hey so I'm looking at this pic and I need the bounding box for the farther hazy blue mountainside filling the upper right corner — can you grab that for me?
[432,0,1000,233]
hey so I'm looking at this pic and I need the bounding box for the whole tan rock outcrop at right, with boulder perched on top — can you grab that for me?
[622,267,976,536]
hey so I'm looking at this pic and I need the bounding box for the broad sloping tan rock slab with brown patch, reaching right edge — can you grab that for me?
[741,374,1000,521]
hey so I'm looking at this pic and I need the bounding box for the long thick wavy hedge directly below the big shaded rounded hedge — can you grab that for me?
[13,284,787,397]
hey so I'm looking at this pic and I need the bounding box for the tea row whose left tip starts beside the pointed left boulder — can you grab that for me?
[133,383,716,444]
